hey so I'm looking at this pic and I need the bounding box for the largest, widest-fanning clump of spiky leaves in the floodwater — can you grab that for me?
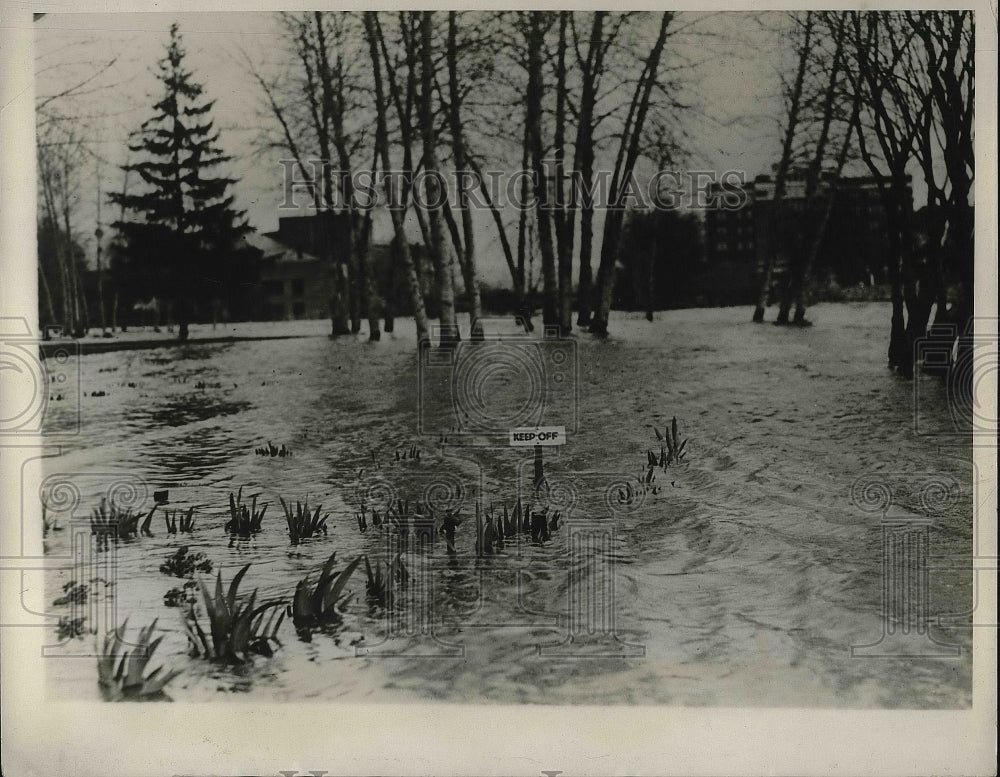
[184,564,285,664]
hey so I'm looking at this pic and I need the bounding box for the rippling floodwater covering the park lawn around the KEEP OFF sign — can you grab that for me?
[43,304,973,708]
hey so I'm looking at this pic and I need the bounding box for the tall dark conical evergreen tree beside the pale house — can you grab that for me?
[111,24,250,340]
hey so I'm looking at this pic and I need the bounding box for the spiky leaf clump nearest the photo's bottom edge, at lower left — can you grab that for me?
[97,618,181,701]
